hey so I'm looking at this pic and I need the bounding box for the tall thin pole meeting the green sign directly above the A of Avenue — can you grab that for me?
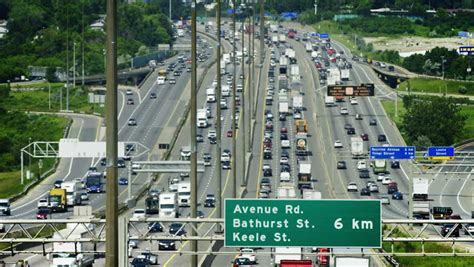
[231,0,237,198]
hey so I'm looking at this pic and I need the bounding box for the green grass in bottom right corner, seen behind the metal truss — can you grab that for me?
[382,230,474,267]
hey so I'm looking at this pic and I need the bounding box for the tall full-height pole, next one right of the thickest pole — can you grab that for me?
[190,0,197,267]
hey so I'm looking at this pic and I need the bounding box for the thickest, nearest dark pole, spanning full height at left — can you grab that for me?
[105,0,118,267]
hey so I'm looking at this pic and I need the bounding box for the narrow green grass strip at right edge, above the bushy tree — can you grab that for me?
[398,78,474,96]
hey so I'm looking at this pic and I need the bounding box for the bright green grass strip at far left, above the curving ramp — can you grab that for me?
[6,83,104,114]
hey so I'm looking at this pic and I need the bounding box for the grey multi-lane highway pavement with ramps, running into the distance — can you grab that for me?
[1,17,473,266]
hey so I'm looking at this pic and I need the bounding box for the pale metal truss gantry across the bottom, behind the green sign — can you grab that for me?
[0,221,474,256]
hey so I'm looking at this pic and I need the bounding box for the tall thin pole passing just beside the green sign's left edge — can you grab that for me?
[216,0,225,233]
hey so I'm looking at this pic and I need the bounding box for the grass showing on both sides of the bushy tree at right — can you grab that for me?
[382,99,474,140]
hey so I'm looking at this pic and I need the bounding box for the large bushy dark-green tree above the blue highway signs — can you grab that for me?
[402,96,467,146]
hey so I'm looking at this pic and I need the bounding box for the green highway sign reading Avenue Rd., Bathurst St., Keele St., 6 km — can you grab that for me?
[224,199,382,248]
